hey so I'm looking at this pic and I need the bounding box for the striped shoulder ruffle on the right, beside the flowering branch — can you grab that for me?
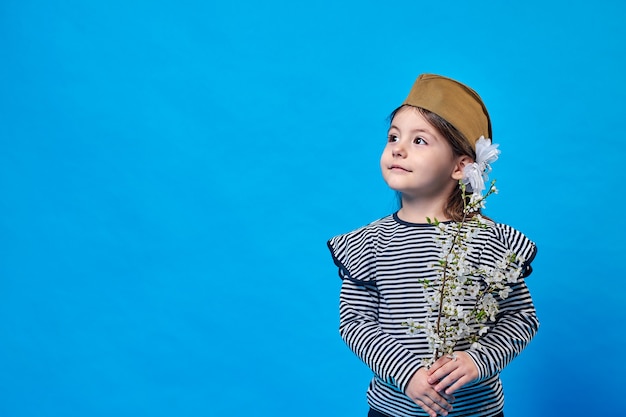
[480,223,537,278]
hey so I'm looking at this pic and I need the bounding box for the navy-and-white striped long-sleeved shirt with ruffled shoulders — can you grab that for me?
[328,214,539,417]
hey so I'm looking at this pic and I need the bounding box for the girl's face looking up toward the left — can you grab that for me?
[380,106,465,201]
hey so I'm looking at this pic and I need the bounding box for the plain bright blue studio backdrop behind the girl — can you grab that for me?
[0,0,626,417]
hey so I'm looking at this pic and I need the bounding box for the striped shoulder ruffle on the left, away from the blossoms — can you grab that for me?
[328,221,377,284]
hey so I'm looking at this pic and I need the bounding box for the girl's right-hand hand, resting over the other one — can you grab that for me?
[428,352,478,395]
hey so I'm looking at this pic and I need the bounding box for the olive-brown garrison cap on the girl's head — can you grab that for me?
[403,74,492,148]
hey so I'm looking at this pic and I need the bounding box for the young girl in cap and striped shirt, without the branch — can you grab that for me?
[328,74,539,417]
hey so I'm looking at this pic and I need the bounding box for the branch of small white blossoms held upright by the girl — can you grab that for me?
[403,137,524,365]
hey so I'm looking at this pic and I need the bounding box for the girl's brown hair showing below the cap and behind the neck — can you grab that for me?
[389,104,478,221]
